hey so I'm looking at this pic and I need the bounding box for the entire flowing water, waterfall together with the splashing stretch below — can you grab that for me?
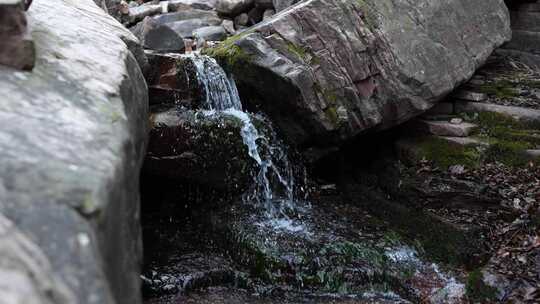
[142,54,465,304]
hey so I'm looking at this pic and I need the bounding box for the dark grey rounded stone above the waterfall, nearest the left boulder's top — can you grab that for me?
[131,17,185,51]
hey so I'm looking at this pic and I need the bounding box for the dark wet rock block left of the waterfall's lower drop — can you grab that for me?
[143,108,255,193]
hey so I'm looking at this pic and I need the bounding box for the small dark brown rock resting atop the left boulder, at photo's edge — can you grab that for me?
[0,0,35,70]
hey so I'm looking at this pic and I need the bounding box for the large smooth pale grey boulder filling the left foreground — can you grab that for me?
[0,0,148,304]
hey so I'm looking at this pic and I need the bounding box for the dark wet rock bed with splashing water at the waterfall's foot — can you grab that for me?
[143,178,470,303]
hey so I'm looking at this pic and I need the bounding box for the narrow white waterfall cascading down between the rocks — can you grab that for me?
[186,54,300,231]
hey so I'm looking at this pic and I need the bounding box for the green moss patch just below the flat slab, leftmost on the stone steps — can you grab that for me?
[408,137,481,170]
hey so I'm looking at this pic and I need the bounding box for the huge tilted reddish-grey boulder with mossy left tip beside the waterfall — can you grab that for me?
[208,0,511,151]
